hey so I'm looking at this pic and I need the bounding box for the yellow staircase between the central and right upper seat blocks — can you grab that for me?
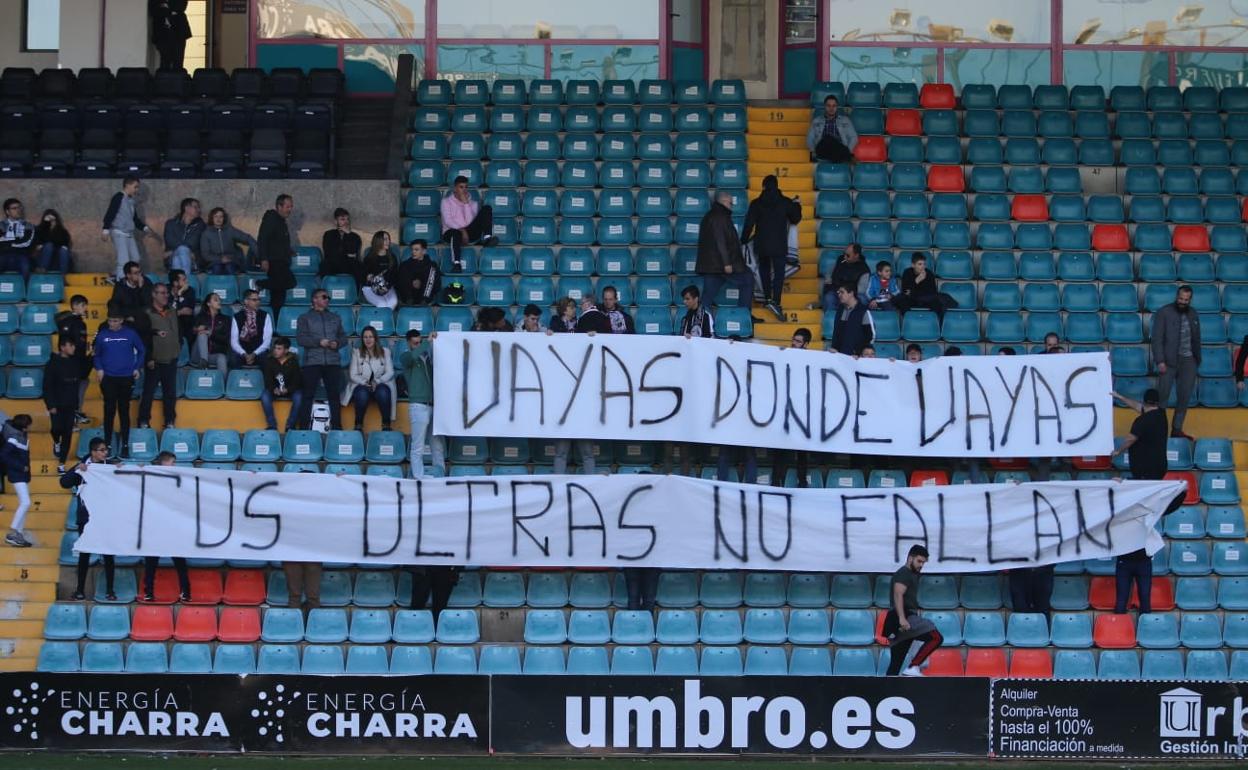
[745,101,824,346]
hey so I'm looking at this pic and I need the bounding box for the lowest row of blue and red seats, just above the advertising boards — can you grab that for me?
[39,641,1248,680]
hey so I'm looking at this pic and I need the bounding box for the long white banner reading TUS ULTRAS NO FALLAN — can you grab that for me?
[75,464,1183,572]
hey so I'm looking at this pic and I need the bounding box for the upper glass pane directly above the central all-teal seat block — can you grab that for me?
[438,0,659,40]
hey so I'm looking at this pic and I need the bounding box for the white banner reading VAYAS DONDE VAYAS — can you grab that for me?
[433,332,1113,457]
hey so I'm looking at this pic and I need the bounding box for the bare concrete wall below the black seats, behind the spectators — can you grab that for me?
[4,178,401,272]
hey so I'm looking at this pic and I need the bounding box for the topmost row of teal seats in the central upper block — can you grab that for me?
[413,77,745,106]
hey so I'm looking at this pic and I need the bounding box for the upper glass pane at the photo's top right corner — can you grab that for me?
[1062,0,1248,47]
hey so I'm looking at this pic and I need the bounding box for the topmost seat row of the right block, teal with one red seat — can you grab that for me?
[810,81,1248,112]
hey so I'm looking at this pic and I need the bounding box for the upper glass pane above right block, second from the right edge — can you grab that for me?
[827,0,1052,44]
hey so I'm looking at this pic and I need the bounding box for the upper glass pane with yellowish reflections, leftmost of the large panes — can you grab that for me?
[256,0,424,40]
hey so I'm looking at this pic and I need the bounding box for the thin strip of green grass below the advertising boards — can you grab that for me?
[0,753,1243,770]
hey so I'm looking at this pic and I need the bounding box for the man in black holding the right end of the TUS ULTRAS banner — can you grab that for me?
[1111,388,1168,615]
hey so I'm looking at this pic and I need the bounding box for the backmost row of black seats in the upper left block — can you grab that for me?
[0,67,343,105]
